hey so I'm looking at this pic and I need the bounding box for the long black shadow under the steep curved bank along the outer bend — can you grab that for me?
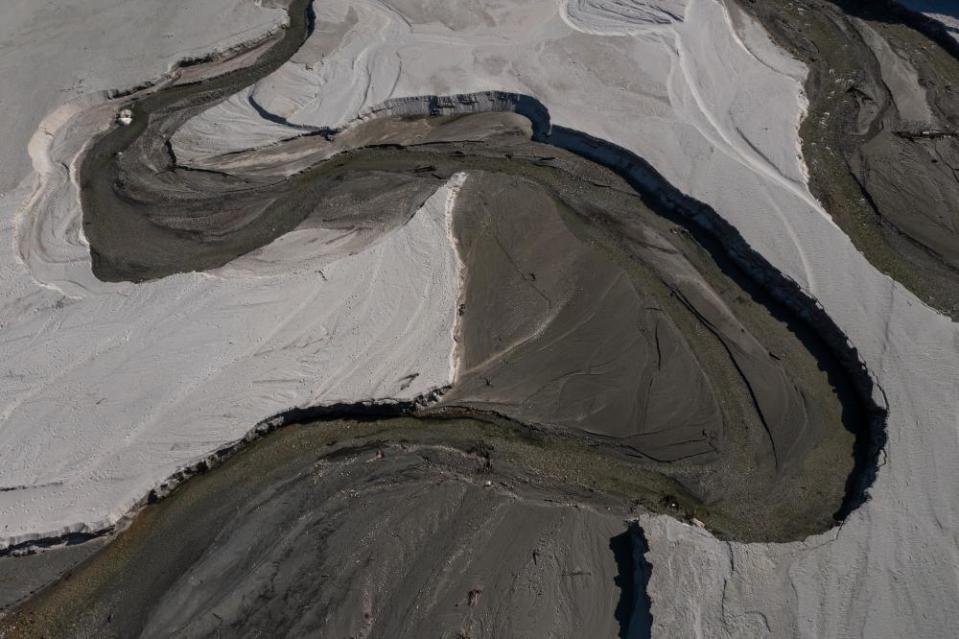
[375,91,887,521]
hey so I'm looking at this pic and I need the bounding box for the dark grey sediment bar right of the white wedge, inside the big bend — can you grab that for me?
[88,124,868,540]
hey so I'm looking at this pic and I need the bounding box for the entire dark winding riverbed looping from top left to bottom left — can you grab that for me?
[0,0,888,637]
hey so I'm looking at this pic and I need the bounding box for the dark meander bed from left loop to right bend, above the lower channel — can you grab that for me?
[84,69,871,539]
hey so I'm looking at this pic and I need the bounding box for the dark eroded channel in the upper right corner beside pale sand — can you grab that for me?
[732,0,959,319]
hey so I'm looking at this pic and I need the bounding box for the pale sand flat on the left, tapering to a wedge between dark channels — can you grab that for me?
[0,3,460,547]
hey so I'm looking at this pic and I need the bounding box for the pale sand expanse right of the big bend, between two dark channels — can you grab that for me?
[163,2,959,636]
